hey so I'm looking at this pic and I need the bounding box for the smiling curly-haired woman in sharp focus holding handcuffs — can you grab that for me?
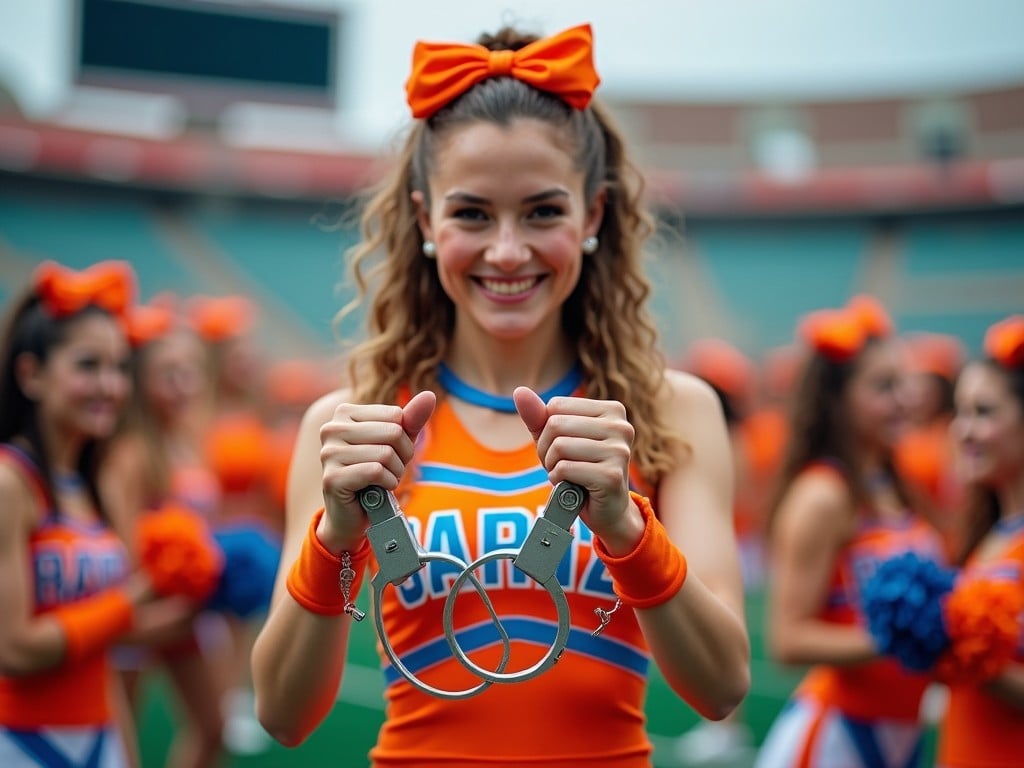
[253,18,750,768]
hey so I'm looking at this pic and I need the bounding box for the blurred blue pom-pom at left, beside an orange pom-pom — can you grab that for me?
[208,524,281,618]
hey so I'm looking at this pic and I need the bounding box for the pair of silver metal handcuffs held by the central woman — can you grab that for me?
[352,481,593,699]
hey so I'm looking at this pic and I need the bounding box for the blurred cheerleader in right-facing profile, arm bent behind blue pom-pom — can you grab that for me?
[757,296,943,768]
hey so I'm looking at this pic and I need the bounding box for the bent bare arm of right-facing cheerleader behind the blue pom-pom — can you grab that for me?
[769,462,879,665]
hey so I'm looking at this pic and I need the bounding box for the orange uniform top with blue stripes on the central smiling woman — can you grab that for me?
[370,400,651,768]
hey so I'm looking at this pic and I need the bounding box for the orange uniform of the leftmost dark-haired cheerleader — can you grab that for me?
[0,445,128,765]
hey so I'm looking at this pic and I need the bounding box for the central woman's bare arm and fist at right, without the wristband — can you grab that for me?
[515,374,750,720]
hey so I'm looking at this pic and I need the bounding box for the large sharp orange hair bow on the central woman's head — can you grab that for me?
[406,24,601,118]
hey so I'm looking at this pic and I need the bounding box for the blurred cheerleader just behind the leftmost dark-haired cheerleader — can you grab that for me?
[103,295,229,768]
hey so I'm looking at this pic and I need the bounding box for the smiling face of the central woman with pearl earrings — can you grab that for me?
[413,118,604,342]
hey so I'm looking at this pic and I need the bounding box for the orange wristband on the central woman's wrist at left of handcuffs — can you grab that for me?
[286,507,371,618]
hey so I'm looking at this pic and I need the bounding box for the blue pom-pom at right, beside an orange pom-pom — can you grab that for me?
[861,552,954,672]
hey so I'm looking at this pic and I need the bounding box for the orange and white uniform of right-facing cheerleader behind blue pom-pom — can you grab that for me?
[758,463,945,768]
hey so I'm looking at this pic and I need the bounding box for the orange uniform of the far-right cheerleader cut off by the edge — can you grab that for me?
[938,529,1024,768]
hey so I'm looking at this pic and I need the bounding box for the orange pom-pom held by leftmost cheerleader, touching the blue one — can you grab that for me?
[135,503,224,602]
